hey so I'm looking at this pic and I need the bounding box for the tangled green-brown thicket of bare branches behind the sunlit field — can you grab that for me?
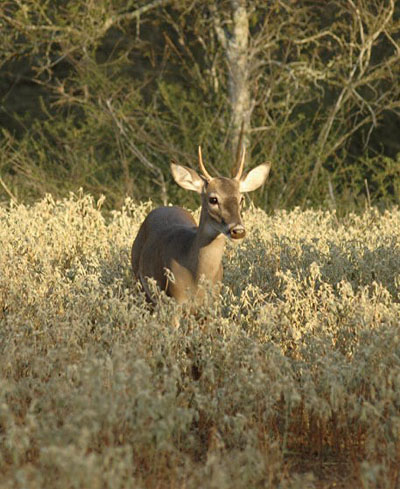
[0,0,400,211]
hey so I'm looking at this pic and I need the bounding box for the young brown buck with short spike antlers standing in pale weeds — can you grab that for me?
[132,146,270,303]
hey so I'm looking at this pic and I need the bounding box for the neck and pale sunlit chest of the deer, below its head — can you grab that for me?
[192,210,225,282]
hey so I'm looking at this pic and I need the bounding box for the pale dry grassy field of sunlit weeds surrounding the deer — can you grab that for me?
[0,195,400,489]
